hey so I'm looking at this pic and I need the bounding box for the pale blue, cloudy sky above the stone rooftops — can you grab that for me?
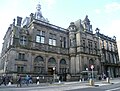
[0,0,120,50]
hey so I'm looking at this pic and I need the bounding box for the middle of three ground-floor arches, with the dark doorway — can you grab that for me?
[48,57,56,75]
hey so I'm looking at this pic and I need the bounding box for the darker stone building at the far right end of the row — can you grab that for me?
[96,28,120,77]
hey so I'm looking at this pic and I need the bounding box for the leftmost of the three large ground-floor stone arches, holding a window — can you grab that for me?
[33,56,45,74]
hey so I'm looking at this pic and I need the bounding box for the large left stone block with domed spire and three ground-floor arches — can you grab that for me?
[1,4,70,81]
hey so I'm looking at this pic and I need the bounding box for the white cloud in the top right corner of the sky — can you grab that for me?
[105,2,120,13]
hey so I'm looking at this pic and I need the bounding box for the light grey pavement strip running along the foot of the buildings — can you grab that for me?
[0,78,120,88]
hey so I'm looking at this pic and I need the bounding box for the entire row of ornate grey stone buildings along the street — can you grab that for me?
[0,4,120,81]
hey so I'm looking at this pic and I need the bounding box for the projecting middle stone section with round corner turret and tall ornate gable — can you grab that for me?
[68,16,101,78]
